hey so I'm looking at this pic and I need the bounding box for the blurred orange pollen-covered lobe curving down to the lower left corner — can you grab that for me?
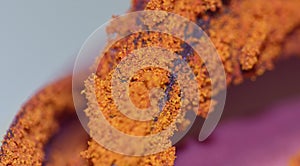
[0,77,80,166]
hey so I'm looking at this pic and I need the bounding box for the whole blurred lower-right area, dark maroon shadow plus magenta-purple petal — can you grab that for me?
[175,58,300,166]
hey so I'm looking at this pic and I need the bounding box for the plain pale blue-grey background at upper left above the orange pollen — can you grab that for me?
[0,0,130,139]
